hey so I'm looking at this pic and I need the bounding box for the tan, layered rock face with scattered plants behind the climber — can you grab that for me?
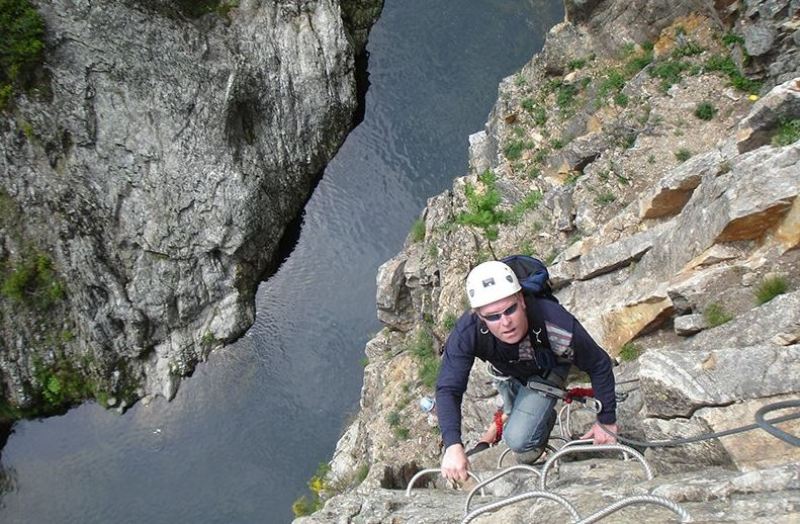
[298,0,800,524]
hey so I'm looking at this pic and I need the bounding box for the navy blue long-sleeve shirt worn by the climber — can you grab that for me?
[436,297,617,447]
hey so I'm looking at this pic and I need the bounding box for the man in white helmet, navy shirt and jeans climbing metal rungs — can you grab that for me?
[436,261,618,481]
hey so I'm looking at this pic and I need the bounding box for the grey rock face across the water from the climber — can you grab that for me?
[0,0,382,407]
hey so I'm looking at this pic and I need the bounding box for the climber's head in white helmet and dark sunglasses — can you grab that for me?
[467,261,528,344]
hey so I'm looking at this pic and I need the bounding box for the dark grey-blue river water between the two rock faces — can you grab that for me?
[0,0,563,524]
